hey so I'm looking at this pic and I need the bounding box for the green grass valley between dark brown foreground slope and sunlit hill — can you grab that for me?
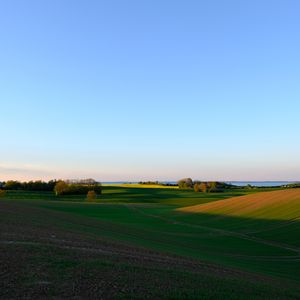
[2,186,300,280]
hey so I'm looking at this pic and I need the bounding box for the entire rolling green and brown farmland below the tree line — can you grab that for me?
[0,185,300,299]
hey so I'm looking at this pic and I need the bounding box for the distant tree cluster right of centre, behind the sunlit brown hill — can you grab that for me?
[177,178,231,193]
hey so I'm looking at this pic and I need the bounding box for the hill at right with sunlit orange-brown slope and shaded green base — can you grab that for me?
[177,189,300,247]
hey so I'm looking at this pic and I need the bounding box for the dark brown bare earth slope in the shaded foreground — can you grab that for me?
[0,201,296,299]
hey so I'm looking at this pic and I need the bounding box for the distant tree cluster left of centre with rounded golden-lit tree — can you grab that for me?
[54,180,102,196]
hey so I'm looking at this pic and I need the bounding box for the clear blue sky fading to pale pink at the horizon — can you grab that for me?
[0,0,300,181]
